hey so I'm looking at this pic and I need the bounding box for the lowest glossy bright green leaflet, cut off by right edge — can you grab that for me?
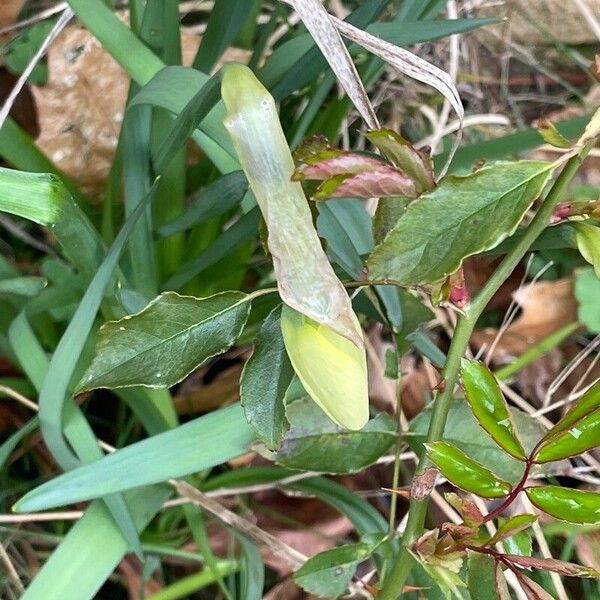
[526,485,600,524]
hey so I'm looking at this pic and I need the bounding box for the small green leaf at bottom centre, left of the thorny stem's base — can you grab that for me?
[294,543,372,598]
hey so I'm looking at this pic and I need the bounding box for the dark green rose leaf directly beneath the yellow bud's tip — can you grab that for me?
[274,396,396,473]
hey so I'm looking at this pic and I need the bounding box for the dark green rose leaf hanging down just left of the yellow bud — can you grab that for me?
[240,307,294,449]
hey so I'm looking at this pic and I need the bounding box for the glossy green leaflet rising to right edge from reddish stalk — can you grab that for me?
[533,383,600,463]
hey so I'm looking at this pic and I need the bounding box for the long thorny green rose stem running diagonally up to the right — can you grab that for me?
[377,146,591,600]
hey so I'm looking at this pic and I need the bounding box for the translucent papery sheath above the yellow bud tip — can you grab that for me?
[222,63,363,347]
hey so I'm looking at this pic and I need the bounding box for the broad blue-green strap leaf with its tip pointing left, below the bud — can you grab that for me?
[15,404,255,512]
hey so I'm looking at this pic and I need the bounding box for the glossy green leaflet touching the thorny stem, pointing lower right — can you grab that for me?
[425,442,512,498]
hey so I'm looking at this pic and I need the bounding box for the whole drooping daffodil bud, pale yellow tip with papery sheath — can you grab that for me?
[222,64,368,429]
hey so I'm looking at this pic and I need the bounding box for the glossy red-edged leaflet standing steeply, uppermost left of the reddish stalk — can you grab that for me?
[461,359,525,460]
